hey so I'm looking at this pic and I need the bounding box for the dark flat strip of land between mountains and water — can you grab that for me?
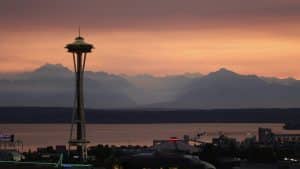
[0,107,300,124]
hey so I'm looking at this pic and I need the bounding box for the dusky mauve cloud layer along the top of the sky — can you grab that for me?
[0,0,300,29]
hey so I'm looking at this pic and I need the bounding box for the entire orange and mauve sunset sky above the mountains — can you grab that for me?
[0,0,300,78]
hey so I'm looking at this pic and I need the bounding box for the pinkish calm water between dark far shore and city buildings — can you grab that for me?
[0,123,299,150]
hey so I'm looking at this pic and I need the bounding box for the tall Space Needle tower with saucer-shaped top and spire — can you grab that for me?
[65,29,94,161]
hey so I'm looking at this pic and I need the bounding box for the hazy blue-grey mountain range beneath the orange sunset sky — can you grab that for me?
[0,64,300,109]
